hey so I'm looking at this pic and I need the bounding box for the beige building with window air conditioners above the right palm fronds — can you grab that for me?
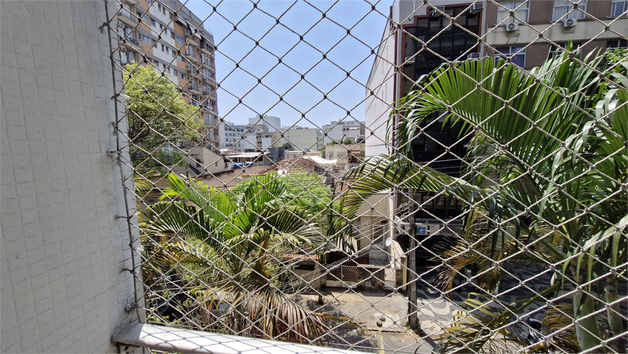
[479,0,628,69]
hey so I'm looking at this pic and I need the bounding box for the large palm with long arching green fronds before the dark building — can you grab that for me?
[343,48,628,351]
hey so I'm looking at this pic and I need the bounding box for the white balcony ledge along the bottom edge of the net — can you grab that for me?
[111,323,368,354]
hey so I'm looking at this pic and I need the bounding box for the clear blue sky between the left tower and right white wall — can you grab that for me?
[185,0,392,127]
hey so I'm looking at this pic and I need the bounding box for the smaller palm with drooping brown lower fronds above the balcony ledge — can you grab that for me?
[140,174,346,343]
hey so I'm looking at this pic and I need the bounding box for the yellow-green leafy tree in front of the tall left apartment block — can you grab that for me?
[123,64,202,172]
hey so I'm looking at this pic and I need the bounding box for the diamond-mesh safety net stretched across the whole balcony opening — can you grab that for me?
[108,0,628,353]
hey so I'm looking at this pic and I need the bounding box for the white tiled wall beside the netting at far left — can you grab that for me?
[0,0,141,353]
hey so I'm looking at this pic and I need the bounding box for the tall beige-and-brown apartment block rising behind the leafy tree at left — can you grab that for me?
[118,0,219,150]
